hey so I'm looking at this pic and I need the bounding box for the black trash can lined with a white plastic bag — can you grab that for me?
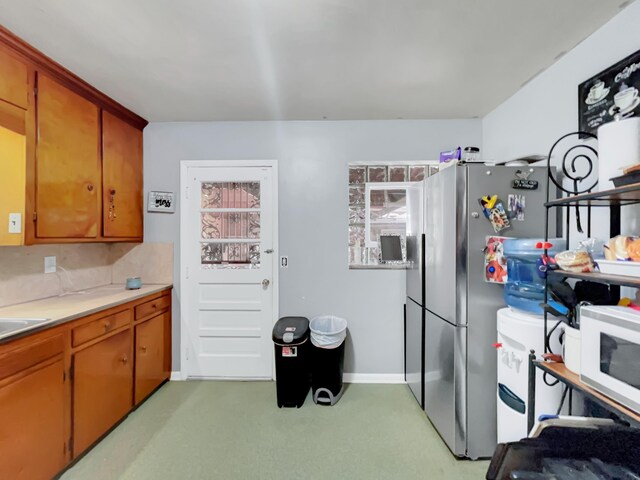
[310,316,347,405]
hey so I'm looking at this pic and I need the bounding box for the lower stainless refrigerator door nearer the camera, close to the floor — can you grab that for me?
[424,310,464,456]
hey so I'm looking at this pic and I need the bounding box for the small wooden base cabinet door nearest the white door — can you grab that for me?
[135,313,169,405]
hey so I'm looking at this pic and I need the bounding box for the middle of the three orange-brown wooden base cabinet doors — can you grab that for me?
[73,330,133,457]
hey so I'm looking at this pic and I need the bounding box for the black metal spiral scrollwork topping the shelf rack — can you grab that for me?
[547,131,598,236]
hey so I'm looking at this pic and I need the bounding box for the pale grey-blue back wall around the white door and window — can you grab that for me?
[144,120,482,374]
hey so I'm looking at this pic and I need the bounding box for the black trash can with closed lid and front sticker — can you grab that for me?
[272,317,311,408]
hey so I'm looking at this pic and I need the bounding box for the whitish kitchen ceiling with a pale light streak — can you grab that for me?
[0,0,628,122]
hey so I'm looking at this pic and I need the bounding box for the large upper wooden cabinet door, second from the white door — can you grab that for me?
[36,75,101,238]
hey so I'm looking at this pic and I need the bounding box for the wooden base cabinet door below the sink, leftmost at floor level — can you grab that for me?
[0,358,66,480]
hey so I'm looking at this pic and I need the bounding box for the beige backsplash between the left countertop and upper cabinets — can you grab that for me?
[0,243,173,306]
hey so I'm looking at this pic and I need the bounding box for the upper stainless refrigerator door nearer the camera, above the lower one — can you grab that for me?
[425,167,466,324]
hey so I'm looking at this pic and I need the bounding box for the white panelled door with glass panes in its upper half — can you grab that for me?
[180,162,277,379]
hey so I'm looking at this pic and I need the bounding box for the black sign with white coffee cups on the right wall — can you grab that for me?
[578,50,640,134]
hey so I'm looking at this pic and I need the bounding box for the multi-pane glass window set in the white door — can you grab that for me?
[200,182,260,269]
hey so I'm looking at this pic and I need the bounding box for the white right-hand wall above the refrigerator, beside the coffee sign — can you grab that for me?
[482,1,640,160]
